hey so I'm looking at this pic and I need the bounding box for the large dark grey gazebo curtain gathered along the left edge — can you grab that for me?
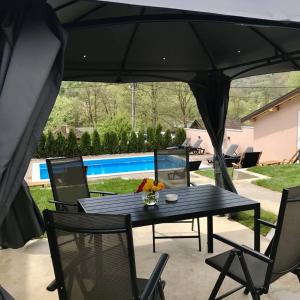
[0,0,66,248]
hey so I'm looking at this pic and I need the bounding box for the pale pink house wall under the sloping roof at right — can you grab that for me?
[253,94,300,161]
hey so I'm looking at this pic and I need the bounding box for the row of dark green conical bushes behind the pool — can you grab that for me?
[35,126,186,158]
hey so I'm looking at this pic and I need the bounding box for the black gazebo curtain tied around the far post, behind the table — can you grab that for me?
[190,71,236,193]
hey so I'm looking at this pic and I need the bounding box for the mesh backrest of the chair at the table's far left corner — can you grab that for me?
[46,157,90,210]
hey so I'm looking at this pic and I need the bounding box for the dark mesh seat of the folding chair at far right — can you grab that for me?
[205,250,268,289]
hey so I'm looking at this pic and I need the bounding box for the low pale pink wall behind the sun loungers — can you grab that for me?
[186,126,254,153]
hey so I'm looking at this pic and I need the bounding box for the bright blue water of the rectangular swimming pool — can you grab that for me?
[39,155,185,180]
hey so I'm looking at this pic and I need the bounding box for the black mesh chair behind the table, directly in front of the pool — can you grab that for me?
[152,148,201,252]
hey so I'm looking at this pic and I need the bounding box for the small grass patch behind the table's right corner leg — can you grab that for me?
[233,209,277,236]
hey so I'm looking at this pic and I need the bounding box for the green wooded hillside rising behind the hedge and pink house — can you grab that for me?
[46,72,300,132]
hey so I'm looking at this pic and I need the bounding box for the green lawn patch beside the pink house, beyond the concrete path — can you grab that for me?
[249,164,300,192]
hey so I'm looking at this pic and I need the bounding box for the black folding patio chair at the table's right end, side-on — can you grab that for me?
[205,187,300,300]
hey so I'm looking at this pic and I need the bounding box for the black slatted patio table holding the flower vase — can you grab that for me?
[78,185,260,253]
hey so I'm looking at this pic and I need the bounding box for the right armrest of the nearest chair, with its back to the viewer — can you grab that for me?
[140,254,169,300]
